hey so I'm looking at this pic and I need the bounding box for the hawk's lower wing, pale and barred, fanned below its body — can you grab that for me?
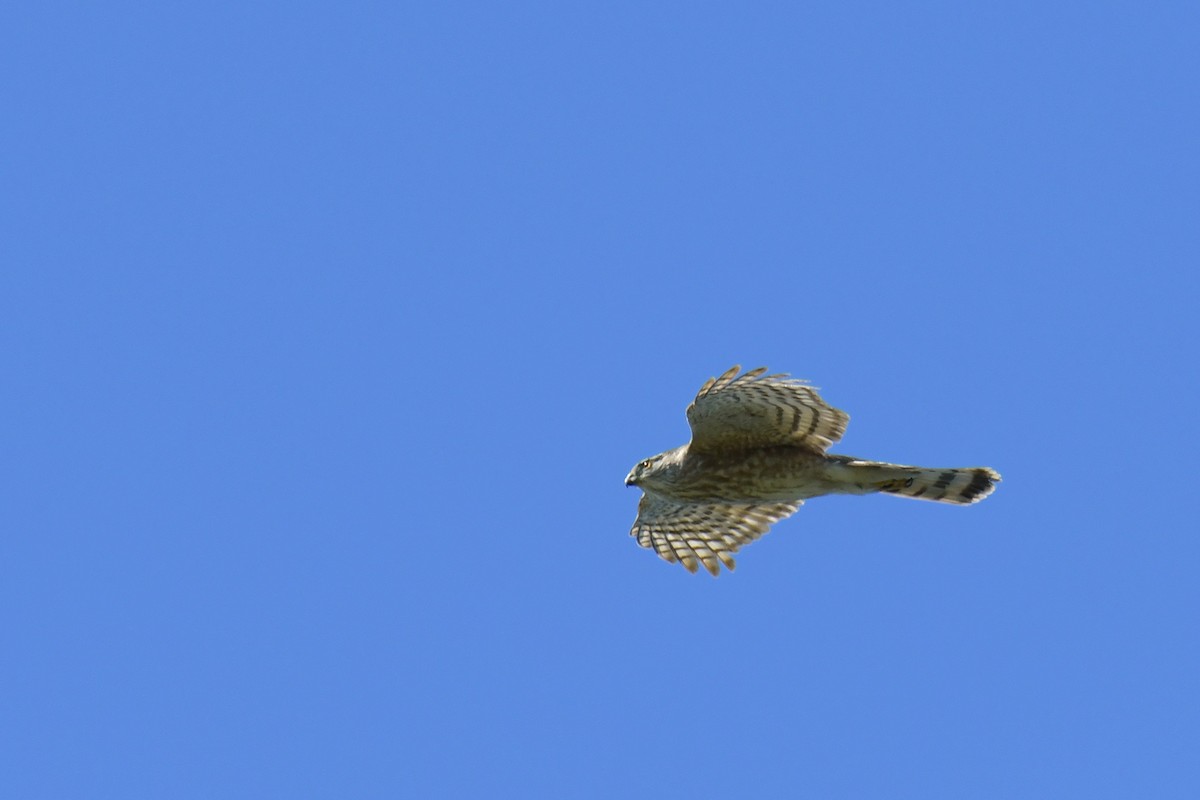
[629,492,802,577]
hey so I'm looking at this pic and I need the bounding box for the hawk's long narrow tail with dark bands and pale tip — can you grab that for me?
[830,456,1000,505]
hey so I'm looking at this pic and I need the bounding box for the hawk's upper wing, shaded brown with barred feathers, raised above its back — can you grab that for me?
[688,367,850,452]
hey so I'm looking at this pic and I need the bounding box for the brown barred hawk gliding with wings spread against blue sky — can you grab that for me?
[625,367,1000,577]
